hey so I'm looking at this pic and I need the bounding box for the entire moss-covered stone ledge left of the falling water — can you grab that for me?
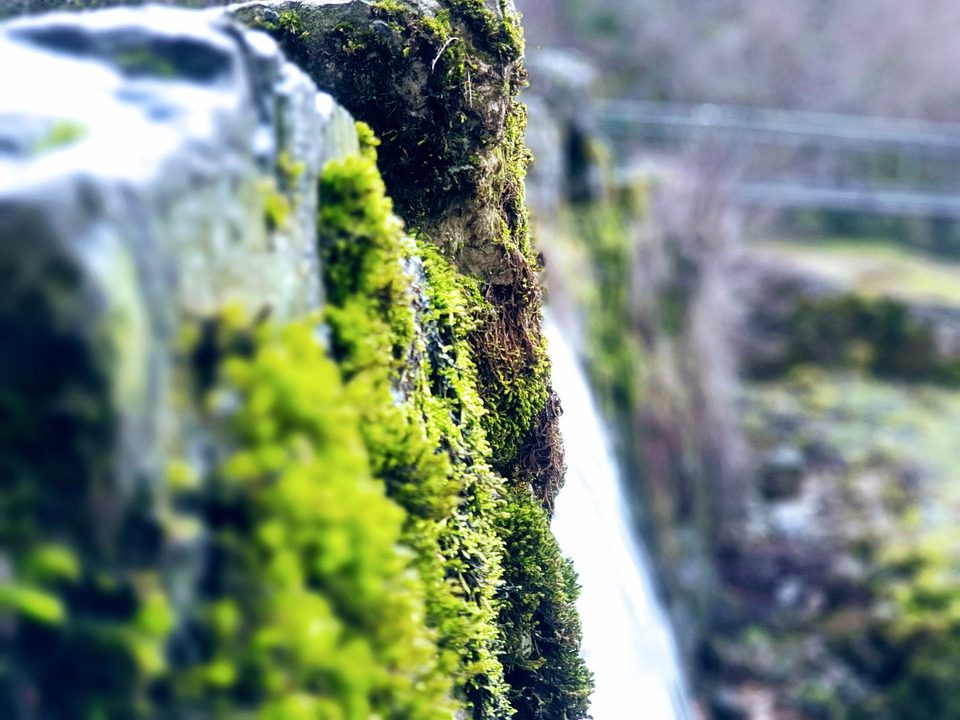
[0,2,590,720]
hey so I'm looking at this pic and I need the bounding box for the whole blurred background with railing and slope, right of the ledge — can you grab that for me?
[518,0,960,720]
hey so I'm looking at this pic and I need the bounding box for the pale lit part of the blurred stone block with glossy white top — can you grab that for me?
[0,7,357,524]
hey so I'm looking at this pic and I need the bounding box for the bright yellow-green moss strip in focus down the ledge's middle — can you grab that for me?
[318,143,507,718]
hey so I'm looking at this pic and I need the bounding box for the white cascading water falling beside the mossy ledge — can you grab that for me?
[546,318,695,720]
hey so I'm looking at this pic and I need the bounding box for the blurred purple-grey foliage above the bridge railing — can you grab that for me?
[520,0,960,121]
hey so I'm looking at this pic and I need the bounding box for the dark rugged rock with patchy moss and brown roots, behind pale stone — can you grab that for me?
[235,0,560,504]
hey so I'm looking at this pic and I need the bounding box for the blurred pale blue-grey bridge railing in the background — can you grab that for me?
[597,100,960,219]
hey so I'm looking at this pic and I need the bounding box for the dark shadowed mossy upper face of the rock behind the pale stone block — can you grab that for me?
[239,0,520,223]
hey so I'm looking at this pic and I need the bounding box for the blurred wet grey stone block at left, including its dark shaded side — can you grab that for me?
[0,9,356,720]
